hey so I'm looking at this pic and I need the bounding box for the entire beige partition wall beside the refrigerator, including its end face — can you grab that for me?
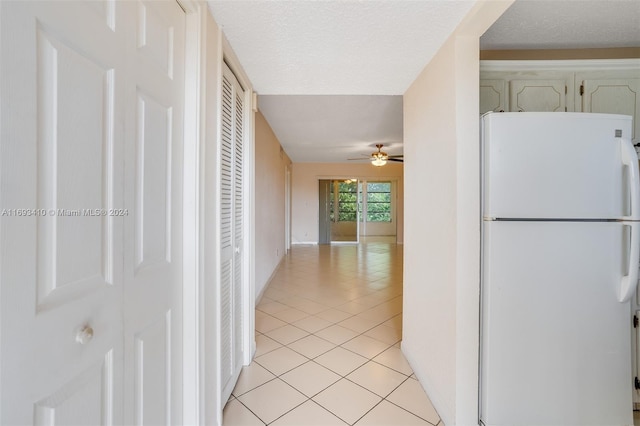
[402,1,511,426]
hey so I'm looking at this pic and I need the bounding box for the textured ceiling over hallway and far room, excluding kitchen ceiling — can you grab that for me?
[209,0,475,162]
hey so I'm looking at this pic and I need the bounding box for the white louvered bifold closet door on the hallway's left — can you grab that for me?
[219,64,244,403]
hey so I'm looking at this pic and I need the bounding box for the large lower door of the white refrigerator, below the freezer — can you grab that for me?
[480,222,633,426]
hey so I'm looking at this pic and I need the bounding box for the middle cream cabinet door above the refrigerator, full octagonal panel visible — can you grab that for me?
[509,80,567,112]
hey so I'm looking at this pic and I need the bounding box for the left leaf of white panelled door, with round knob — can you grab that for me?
[0,2,127,425]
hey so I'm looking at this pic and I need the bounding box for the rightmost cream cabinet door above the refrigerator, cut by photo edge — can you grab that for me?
[579,78,640,143]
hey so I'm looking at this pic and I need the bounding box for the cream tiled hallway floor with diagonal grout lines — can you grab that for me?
[224,243,443,426]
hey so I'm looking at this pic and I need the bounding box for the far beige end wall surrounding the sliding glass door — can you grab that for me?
[291,163,404,244]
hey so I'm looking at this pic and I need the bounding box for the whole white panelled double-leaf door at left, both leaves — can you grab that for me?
[0,1,185,425]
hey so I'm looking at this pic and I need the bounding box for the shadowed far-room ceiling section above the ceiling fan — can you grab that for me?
[258,95,402,163]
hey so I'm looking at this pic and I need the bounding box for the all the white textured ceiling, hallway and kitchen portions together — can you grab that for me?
[209,0,640,162]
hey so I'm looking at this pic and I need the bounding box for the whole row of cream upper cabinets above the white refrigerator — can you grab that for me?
[480,59,640,143]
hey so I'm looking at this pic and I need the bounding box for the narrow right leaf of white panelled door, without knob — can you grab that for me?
[124,0,185,425]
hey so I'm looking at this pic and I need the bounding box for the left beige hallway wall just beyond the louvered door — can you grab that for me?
[255,111,291,298]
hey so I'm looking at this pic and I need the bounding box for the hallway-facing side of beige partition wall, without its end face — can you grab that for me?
[402,31,457,425]
